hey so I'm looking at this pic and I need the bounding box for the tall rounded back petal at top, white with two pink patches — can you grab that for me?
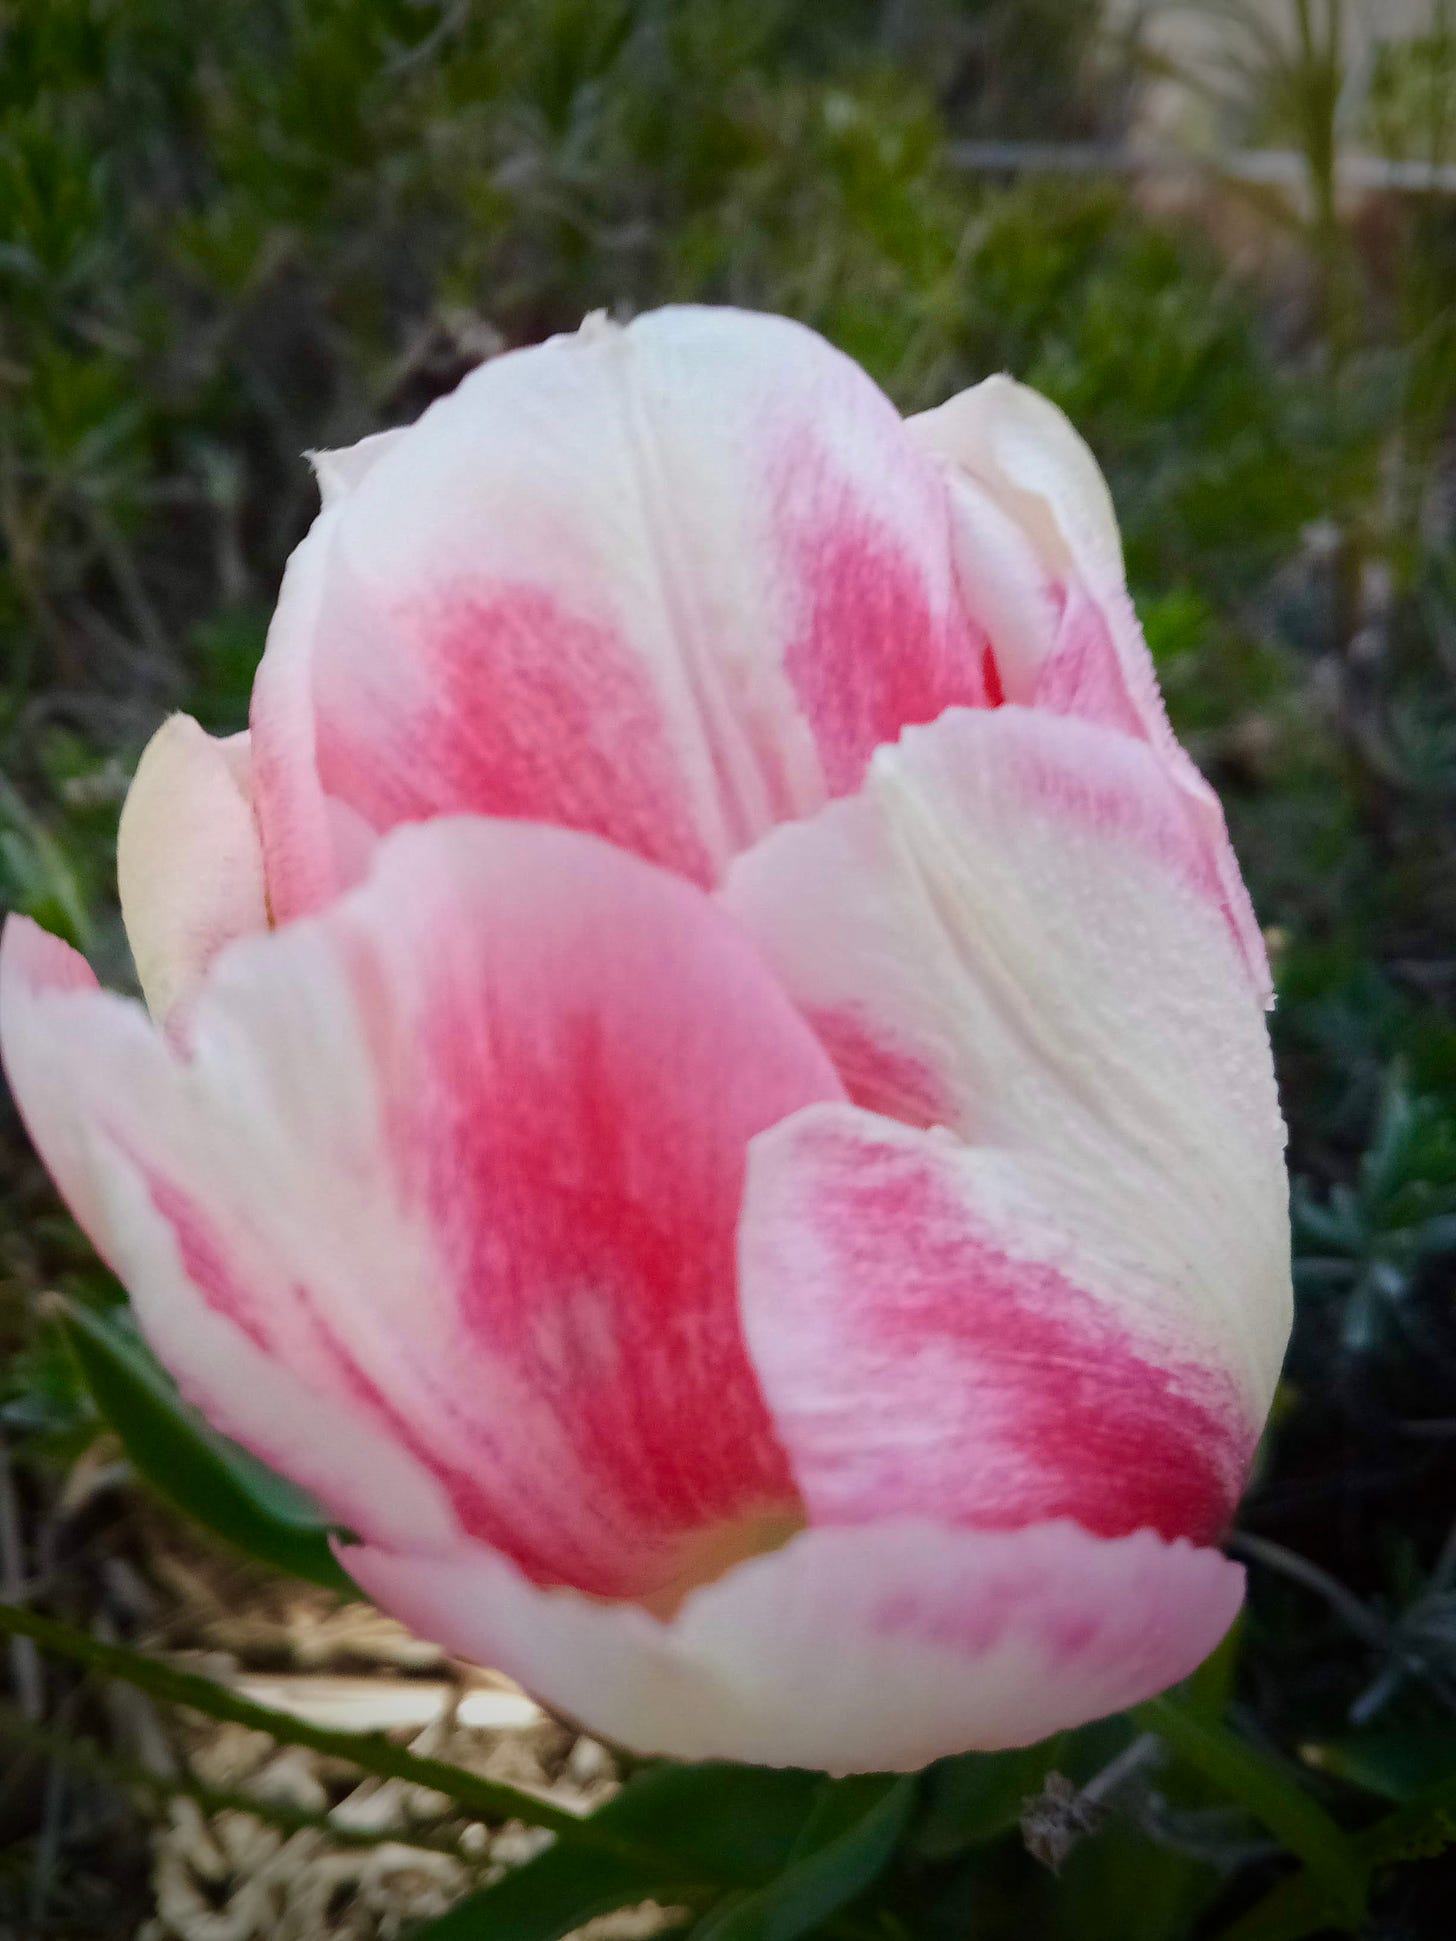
[254,309,984,914]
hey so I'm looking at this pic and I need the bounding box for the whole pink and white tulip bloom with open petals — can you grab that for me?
[0,309,1289,1770]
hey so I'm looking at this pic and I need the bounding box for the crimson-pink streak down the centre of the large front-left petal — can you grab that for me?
[399,986,796,1596]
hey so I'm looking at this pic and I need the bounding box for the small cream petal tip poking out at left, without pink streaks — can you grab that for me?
[116,714,268,1021]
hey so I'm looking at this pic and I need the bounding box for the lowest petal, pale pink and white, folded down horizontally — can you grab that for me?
[346,1522,1242,1772]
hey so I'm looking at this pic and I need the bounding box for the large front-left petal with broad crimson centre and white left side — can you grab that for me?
[4,821,839,1596]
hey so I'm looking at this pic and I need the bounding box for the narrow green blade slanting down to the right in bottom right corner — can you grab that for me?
[1134,1694,1369,1925]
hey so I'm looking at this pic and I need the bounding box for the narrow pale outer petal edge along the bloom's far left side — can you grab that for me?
[0,916,460,1543]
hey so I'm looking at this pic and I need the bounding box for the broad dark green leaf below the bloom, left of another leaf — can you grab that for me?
[412,1764,825,1941]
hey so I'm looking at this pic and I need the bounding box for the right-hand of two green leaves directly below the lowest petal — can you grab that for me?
[693,1772,916,1941]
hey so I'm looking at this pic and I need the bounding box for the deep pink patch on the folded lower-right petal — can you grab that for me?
[790,1128,1250,1543]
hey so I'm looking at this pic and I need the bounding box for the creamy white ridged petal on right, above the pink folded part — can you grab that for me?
[722,707,1289,1423]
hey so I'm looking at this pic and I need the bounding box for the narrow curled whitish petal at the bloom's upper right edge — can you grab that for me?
[909,377,1272,1003]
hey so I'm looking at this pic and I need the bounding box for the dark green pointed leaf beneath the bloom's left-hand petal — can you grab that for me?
[60,1300,357,1596]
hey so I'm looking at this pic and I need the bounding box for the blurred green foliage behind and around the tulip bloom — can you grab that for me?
[0,0,1456,1941]
